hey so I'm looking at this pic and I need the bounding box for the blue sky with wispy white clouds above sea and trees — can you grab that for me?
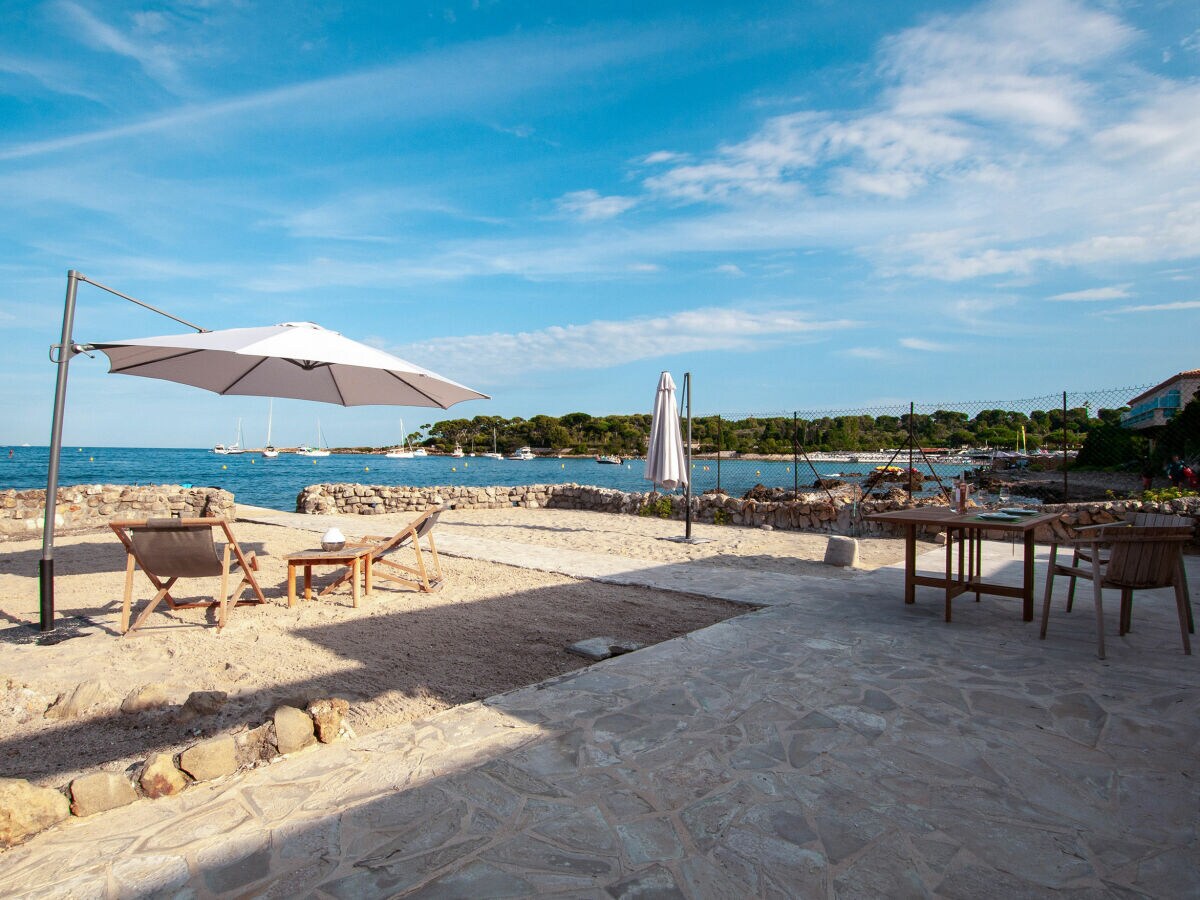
[0,0,1200,446]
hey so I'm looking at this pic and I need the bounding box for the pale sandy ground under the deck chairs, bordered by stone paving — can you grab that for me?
[0,509,902,786]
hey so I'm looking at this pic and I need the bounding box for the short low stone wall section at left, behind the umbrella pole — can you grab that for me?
[0,485,234,538]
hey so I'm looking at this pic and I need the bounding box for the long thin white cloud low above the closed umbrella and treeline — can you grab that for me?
[396,307,857,384]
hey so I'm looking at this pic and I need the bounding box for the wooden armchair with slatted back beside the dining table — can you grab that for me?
[1040,521,1194,659]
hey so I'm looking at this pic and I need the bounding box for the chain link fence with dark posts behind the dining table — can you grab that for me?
[691,385,1161,502]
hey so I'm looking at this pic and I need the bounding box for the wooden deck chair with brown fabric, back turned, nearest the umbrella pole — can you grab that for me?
[109,518,266,635]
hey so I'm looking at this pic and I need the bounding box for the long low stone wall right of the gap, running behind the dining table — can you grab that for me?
[296,484,1200,542]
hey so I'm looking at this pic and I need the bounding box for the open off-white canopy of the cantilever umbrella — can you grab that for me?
[91,322,488,409]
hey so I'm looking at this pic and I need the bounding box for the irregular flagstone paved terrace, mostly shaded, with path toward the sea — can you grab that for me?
[0,511,1200,898]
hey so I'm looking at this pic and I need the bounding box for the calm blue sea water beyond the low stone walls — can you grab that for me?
[0,445,961,511]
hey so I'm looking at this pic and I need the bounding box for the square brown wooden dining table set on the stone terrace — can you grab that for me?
[865,506,1060,622]
